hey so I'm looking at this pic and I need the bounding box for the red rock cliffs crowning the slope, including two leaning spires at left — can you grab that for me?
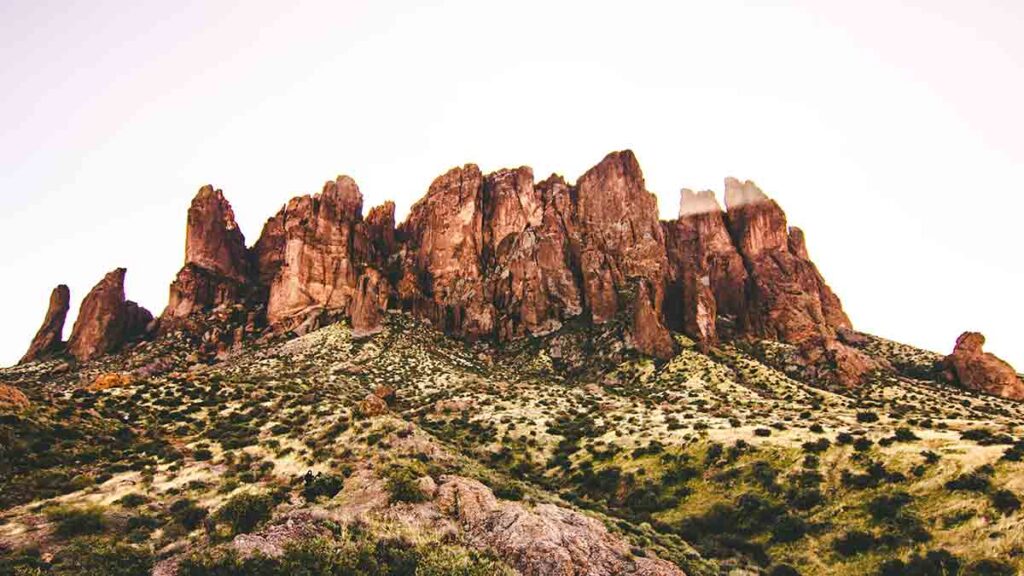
[19,151,905,384]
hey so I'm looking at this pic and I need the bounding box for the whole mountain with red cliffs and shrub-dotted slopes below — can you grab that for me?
[0,151,1024,576]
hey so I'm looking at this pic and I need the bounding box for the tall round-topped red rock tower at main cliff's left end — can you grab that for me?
[162,184,251,331]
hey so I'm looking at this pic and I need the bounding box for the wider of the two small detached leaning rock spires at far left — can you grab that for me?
[68,269,153,362]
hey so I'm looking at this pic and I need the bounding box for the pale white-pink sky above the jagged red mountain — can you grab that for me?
[0,0,1024,370]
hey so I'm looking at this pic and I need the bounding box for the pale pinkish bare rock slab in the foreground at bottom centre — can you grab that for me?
[435,477,684,576]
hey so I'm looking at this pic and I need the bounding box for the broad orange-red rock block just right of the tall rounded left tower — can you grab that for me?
[264,176,362,325]
